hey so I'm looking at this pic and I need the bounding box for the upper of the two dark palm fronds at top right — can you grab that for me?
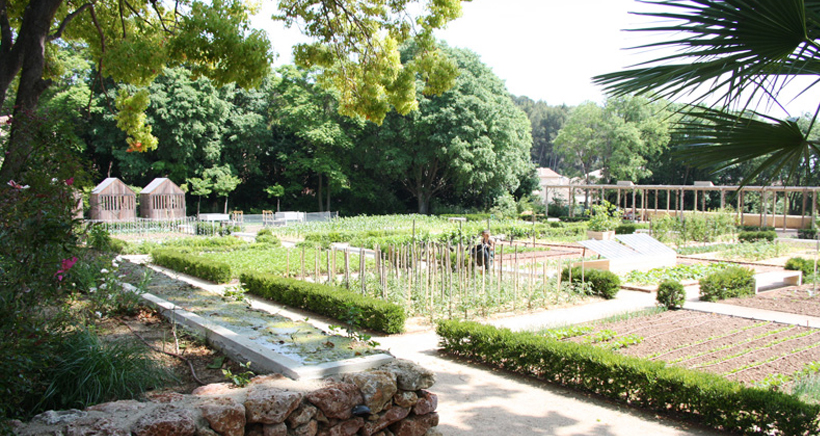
[593,0,820,102]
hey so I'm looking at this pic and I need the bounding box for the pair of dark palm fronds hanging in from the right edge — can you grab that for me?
[594,0,820,183]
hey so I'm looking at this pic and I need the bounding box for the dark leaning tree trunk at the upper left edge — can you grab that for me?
[0,0,63,185]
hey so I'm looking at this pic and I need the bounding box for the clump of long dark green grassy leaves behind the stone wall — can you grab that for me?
[36,329,173,410]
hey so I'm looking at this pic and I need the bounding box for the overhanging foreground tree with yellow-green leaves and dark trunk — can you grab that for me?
[0,0,461,182]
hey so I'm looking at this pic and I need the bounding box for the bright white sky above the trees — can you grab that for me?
[255,0,820,115]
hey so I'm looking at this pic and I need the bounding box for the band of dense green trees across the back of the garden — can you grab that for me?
[3,39,820,215]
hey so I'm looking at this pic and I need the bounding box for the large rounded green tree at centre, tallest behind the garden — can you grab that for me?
[354,47,532,214]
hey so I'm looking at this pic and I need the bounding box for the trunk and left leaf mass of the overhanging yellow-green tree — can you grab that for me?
[0,0,272,180]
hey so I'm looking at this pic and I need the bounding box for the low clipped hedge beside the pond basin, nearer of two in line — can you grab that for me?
[240,272,407,334]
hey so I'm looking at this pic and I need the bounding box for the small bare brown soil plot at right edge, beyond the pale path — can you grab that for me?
[721,284,820,317]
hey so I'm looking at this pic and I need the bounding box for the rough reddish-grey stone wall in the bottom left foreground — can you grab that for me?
[15,360,440,436]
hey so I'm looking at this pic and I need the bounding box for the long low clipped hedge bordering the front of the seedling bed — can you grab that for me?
[437,321,820,435]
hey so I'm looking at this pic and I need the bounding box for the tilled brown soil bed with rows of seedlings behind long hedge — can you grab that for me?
[566,310,820,384]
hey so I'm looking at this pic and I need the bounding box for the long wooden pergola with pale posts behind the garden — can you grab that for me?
[547,181,820,230]
